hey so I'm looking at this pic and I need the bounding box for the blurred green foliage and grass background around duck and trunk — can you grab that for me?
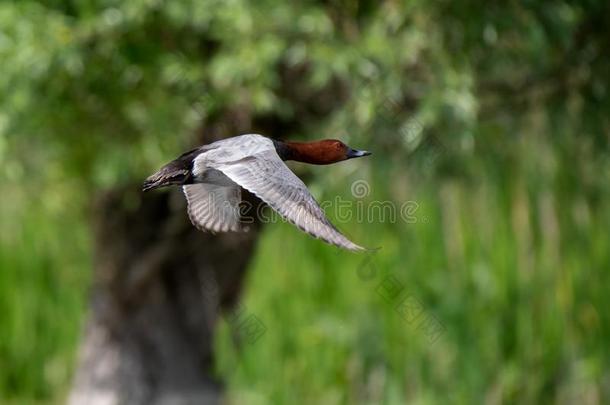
[0,0,610,404]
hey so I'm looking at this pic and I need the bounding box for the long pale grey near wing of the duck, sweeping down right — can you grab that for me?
[206,149,364,251]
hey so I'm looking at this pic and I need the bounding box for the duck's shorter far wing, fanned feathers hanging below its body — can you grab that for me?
[182,183,241,232]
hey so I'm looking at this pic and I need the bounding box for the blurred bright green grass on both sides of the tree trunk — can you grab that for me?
[0,175,610,404]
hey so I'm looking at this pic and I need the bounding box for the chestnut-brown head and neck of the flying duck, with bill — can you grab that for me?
[276,139,371,165]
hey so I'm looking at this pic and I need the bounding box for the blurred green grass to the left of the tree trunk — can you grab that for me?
[0,184,91,404]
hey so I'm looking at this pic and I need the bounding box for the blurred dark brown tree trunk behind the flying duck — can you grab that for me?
[70,114,258,405]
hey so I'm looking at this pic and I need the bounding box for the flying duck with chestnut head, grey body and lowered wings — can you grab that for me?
[143,134,371,251]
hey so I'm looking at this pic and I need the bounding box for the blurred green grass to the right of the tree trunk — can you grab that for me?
[217,181,610,404]
